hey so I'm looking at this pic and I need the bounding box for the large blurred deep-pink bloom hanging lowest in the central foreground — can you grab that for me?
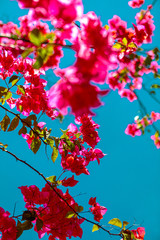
[48,79,109,116]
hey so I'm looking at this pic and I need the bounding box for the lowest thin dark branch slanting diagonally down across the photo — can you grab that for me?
[0,147,122,237]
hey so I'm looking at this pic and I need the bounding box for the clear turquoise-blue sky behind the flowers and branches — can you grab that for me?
[0,0,160,240]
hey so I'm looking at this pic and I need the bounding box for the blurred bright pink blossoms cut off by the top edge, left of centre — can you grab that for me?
[15,0,83,26]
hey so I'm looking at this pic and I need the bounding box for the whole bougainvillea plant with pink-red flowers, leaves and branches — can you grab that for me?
[0,0,160,240]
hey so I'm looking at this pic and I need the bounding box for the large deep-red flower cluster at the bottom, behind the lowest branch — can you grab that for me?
[18,184,84,240]
